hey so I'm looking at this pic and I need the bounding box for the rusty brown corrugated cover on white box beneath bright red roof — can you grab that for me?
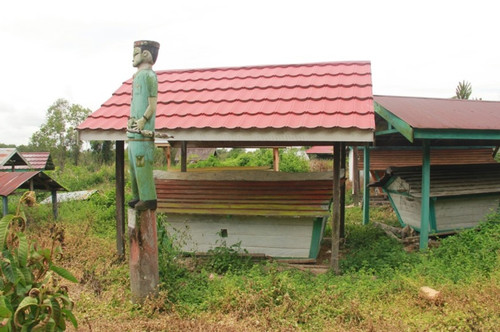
[156,179,332,217]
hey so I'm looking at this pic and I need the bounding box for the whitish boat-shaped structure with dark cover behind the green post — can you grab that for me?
[372,163,500,233]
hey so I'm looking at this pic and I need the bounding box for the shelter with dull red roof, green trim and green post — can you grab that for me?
[370,96,500,248]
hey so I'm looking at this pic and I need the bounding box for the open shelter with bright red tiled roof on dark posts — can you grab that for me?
[77,61,375,264]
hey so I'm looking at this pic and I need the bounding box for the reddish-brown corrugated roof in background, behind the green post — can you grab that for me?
[358,148,496,171]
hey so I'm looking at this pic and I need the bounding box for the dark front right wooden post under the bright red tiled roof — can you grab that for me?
[330,143,343,274]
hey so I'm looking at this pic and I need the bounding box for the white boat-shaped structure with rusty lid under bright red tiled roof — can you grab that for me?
[155,170,333,259]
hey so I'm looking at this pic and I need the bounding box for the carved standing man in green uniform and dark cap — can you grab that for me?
[127,40,160,211]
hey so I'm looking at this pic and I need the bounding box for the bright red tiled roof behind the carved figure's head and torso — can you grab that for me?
[78,62,375,131]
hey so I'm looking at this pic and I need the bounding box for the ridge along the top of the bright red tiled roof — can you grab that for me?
[155,60,371,75]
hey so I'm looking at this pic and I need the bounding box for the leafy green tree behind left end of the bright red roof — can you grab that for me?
[30,99,90,168]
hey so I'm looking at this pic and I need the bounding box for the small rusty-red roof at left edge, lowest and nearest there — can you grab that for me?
[0,171,66,196]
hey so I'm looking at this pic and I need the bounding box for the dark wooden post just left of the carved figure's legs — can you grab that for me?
[115,141,125,259]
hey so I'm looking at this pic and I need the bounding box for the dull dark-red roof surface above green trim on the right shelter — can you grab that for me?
[373,96,500,130]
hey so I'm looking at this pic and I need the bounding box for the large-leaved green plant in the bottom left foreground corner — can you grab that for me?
[0,194,78,331]
